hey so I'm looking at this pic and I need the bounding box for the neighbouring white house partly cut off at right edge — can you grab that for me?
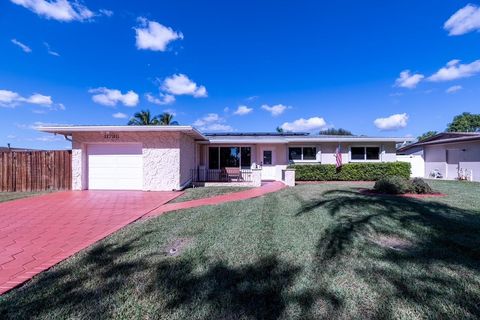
[398,132,480,181]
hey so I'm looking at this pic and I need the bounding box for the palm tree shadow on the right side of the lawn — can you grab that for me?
[296,190,480,318]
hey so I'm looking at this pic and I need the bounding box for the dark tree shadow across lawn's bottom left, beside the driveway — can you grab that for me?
[0,233,341,319]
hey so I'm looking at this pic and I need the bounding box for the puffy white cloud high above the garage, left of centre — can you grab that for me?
[134,17,183,51]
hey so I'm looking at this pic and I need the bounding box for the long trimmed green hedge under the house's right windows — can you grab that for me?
[289,162,411,181]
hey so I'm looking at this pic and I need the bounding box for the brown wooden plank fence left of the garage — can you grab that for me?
[0,150,72,192]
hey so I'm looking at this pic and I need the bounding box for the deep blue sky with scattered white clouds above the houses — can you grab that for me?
[0,0,480,149]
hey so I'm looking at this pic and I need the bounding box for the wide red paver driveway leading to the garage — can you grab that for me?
[0,191,181,294]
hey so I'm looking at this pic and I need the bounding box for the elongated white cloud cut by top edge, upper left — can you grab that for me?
[10,0,95,21]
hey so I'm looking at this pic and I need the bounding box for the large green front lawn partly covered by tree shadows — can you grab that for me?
[0,181,480,319]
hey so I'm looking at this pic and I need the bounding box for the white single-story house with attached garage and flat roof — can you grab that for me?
[39,126,411,191]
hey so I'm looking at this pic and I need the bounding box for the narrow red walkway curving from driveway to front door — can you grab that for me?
[144,181,286,218]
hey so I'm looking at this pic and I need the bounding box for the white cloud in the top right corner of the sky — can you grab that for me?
[443,4,480,36]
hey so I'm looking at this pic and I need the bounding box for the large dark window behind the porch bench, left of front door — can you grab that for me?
[208,147,252,169]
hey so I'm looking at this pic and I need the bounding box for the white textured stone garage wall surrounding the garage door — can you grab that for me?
[72,132,190,191]
